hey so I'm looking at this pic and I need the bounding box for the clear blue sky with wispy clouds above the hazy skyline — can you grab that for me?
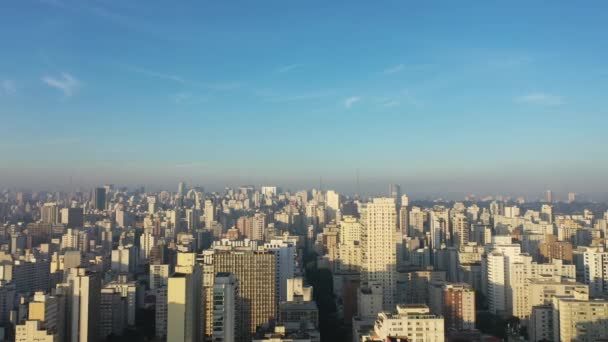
[0,0,608,197]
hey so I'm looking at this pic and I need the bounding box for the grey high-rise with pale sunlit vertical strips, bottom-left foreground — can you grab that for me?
[67,267,101,342]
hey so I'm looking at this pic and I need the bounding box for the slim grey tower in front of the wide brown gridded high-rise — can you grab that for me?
[212,272,243,342]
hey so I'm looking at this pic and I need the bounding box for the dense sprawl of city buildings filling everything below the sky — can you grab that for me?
[0,182,608,342]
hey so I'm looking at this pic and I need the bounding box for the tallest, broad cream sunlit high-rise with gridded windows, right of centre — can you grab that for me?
[361,198,397,310]
